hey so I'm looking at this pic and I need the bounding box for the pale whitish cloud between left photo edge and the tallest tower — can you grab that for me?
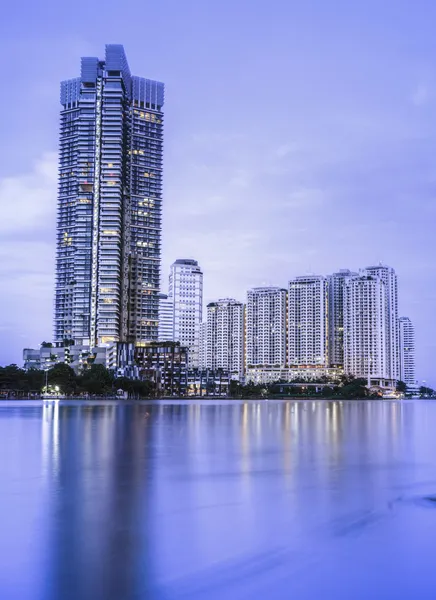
[0,153,57,363]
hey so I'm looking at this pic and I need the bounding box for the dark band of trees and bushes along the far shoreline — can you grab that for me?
[0,363,436,400]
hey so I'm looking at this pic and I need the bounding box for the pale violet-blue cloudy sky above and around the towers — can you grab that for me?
[0,0,436,385]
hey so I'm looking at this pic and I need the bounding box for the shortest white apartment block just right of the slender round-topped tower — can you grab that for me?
[206,298,244,378]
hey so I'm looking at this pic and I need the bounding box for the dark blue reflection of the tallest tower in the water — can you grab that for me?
[42,403,154,600]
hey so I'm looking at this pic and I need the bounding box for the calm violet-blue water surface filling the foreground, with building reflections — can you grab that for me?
[0,401,436,600]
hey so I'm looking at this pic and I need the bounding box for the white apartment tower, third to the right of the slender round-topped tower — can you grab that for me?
[288,275,329,366]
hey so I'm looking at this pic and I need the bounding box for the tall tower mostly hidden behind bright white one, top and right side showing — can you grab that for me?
[362,264,400,379]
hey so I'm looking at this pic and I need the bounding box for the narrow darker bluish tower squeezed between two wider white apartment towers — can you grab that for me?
[327,269,357,367]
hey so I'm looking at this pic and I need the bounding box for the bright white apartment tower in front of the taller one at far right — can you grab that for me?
[344,275,390,378]
